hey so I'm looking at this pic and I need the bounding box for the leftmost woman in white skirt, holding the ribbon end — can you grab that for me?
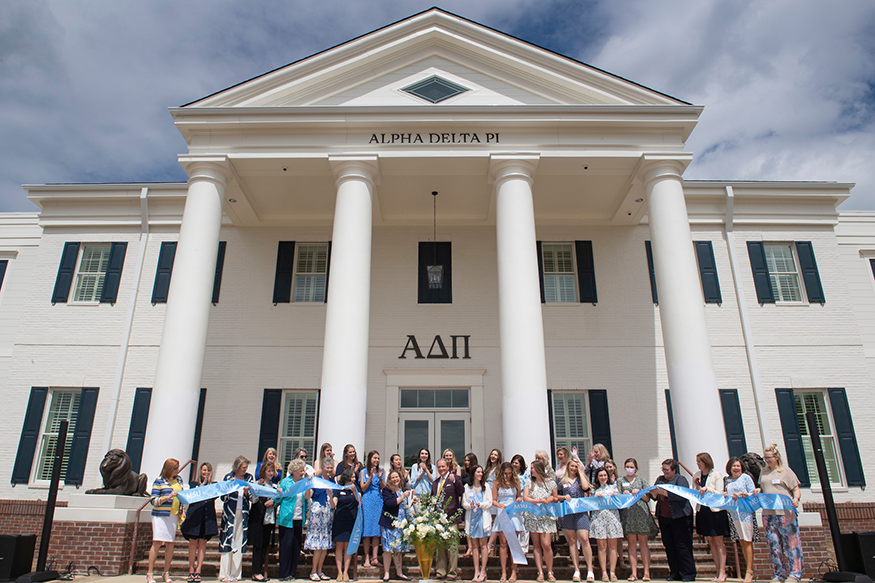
[146,458,188,583]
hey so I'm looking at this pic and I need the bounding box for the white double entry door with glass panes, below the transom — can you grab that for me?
[398,411,471,468]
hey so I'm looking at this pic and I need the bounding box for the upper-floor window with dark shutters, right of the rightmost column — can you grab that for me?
[747,241,826,304]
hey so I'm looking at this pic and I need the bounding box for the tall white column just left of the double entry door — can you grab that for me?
[317,157,377,452]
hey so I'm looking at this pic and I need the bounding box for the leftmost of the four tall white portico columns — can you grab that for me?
[141,163,227,480]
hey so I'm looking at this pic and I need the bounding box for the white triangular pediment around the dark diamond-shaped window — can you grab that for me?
[185,8,684,108]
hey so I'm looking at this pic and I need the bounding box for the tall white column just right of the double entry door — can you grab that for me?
[490,156,550,458]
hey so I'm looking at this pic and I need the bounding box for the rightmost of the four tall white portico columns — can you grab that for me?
[643,161,729,469]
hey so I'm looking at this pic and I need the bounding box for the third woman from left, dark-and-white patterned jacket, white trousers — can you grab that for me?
[219,455,257,581]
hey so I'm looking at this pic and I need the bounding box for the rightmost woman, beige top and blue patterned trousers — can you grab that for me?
[754,443,803,583]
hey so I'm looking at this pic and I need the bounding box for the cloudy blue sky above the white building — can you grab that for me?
[0,0,875,211]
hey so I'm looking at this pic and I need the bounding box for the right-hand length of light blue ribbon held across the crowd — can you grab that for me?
[507,484,798,518]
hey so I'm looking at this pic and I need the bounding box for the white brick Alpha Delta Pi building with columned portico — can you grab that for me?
[0,9,875,502]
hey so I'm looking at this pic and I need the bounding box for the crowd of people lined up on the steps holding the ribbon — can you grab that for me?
[147,443,802,583]
